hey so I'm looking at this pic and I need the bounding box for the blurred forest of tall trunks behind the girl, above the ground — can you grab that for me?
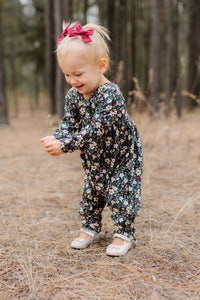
[0,0,200,124]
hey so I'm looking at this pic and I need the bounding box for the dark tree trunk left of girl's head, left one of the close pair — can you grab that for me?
[45,0,56,114]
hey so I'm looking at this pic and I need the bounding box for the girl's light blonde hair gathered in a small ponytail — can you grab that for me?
[56,23,110,69]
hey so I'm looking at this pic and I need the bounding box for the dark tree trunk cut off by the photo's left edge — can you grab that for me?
[0,3,8,127]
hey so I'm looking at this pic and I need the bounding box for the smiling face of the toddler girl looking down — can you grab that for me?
[58,52,107,99]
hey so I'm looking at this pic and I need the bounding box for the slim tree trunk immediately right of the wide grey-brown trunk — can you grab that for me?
[165,0,173,117]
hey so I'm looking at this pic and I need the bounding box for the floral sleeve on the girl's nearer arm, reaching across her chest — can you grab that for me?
[60,92,126,152]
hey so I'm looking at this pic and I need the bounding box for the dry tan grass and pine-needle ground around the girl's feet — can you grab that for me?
[0,111,200,300]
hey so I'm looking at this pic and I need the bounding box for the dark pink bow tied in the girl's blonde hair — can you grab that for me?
[57,22,94,43]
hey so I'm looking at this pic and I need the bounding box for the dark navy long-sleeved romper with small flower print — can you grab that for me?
[54,82,143,240]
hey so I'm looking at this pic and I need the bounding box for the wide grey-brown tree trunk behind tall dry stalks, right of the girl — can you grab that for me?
[150,0,160,111]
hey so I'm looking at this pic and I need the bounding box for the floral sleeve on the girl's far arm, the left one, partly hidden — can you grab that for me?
[54,89,80,140]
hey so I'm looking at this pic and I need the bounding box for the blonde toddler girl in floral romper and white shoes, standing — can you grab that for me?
[41,23,142,256]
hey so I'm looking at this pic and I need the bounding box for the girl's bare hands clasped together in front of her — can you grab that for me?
[40,136,63,156]
